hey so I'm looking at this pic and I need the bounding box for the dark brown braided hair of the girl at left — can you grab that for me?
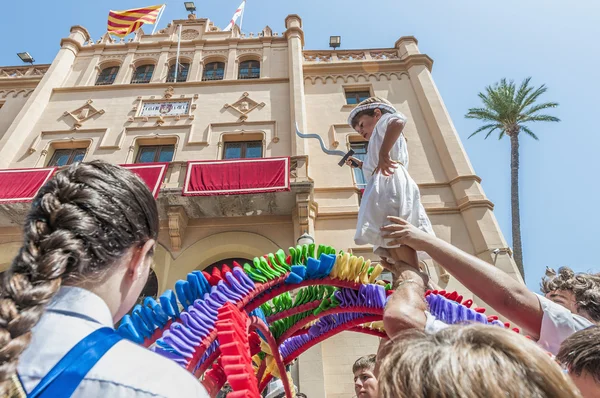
[0,161,158,395]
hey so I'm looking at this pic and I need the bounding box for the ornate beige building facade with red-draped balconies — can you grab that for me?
[0,15,521,398]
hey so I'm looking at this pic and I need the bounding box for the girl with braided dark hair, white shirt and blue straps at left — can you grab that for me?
[0,161,208,398]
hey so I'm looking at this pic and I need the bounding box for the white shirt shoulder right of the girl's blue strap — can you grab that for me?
[90,340,208,397]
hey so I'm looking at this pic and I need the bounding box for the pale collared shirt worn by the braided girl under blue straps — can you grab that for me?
[18,287,209,398]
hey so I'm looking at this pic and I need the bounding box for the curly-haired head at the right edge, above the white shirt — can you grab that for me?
[541,267,600,323]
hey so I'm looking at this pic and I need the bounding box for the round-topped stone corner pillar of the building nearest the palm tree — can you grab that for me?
[396,37,523,281]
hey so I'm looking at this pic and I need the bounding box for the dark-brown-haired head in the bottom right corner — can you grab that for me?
[556,326,600,398]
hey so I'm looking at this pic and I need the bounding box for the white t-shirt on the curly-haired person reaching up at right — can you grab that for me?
[536,294,594,355]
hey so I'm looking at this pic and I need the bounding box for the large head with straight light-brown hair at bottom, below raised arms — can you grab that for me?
[378,324,579,398]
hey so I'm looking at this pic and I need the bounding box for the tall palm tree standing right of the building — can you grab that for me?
[465,77,560,278]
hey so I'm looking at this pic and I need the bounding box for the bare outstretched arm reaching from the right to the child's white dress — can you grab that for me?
[382,217,544,340]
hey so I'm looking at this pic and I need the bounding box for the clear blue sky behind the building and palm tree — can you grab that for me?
[0,0,600,291]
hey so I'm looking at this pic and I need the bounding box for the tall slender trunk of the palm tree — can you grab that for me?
[510,130,525,279]
